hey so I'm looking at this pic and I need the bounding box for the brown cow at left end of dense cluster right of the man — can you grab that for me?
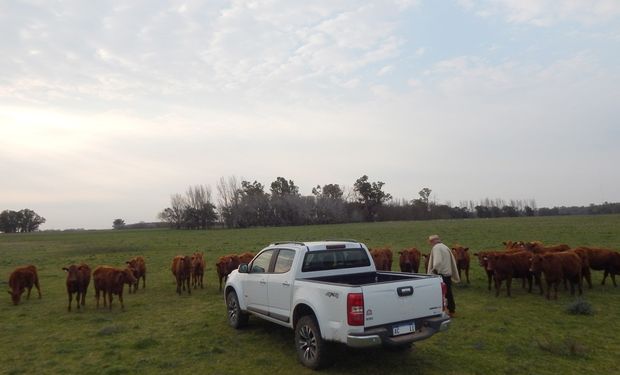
[487,251,532,297]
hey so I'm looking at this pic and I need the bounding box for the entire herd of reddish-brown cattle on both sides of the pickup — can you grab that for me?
[8,241,620,311]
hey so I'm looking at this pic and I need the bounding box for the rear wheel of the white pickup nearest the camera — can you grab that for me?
[295,315,332,370]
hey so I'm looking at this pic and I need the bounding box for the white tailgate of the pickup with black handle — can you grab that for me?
[362,277,443,327]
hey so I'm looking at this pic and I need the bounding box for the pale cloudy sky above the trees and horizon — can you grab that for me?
[0,0,620,229]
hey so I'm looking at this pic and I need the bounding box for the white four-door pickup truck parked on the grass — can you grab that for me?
[224,240,450,369]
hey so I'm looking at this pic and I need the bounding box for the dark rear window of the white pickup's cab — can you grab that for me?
[301,248,370,272]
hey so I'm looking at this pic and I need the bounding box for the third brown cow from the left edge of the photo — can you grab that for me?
[93,266,136,310]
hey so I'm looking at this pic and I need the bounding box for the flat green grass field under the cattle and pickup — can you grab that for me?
[0,215,620,375]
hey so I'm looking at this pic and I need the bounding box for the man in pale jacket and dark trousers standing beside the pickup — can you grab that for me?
[426,234,461,317]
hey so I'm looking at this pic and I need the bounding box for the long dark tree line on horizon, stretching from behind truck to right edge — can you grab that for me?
[153,175,620,229]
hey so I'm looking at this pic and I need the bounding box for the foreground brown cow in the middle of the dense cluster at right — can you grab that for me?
[531,252,583,299]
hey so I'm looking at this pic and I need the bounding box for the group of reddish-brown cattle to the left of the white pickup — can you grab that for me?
[8,252,254,311]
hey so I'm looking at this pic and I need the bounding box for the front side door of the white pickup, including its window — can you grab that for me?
[242,250,275,315]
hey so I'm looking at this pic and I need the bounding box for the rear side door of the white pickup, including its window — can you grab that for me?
[267,249,295,322]
